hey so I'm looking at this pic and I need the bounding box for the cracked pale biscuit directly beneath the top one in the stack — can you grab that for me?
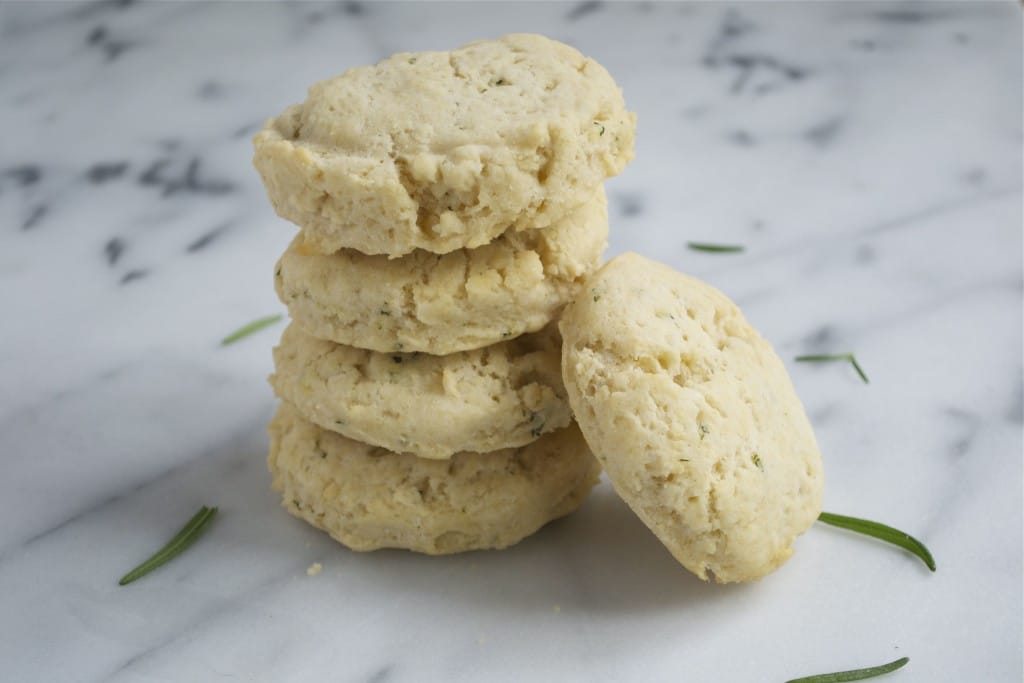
[274,189,608,354]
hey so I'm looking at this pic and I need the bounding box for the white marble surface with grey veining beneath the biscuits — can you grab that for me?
[0,2,1022,683]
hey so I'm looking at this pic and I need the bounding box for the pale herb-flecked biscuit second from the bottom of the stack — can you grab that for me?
[270,324,571,459]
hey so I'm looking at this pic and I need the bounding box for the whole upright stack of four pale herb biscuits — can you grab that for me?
[254,35,635,554]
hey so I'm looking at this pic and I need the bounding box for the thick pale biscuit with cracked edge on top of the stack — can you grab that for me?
[253,34,635,256]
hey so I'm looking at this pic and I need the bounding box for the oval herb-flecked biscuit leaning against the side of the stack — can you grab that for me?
[560,254,822,583]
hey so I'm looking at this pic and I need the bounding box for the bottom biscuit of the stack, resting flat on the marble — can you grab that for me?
[268,403,600,555]
